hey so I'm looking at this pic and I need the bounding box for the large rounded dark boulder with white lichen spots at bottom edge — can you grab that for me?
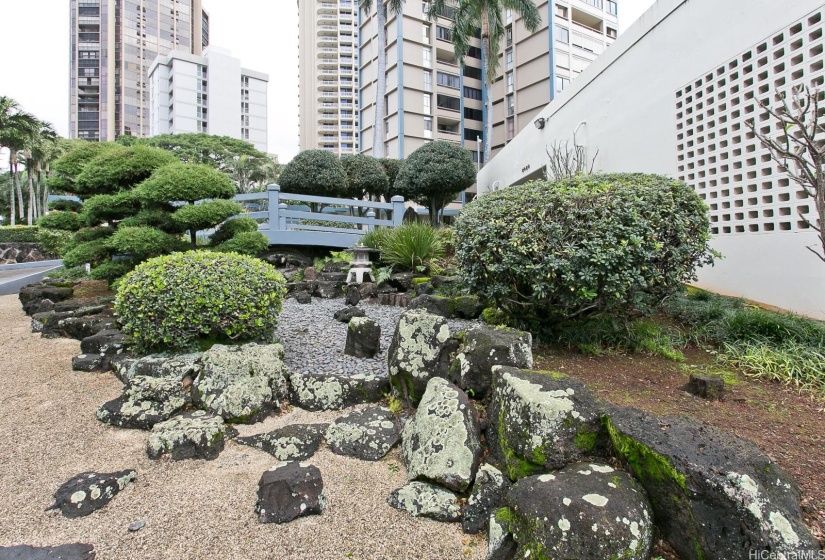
[497,463,652,560]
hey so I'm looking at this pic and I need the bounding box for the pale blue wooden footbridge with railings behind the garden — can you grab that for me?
[233,185,405,248]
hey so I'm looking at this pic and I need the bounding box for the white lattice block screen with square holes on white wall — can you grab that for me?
[676,6,825,235]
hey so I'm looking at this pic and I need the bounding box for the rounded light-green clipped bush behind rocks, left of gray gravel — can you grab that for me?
[115,251,286,350]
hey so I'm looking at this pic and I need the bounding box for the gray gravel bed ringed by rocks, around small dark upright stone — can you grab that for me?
[275,298,474,375]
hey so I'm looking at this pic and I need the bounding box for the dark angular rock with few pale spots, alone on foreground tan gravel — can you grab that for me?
[255,462,326,523]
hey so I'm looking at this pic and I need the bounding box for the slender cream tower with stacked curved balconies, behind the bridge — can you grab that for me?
[298,0,359,155]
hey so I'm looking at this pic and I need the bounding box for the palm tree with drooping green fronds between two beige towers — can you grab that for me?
[429,0,541,163]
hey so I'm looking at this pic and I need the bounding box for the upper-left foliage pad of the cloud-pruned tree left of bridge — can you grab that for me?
[75,145,175,197]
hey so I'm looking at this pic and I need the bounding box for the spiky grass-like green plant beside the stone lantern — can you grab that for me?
[380,222,444,272]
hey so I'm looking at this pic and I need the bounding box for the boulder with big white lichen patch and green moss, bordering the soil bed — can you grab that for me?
[487,366,607,480]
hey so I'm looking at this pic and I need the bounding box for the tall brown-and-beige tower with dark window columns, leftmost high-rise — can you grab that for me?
[69,0,209,141]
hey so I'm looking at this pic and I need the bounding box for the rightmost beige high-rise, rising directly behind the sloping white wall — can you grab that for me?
[492,0,619,154]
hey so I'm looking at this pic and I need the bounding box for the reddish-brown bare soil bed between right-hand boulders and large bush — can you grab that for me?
[533,346,825,558]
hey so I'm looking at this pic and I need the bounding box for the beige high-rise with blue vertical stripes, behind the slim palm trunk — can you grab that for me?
[359,2,483,159]
